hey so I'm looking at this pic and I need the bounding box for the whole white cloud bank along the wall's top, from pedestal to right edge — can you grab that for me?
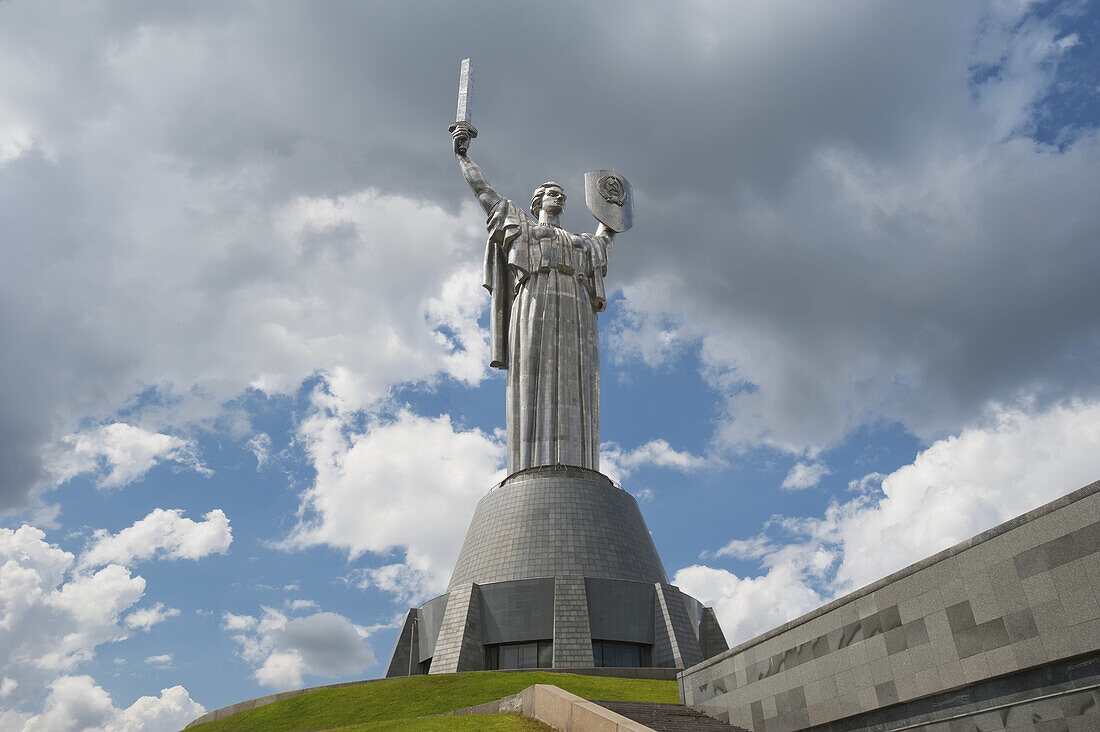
[673,402,1100,643]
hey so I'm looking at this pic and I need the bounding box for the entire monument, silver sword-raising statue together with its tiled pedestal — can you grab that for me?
[386,59,726,679]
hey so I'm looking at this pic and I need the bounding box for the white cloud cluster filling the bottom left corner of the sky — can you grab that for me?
[0,525,204,732]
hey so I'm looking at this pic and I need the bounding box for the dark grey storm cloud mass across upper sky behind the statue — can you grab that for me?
[0,2,1100,507]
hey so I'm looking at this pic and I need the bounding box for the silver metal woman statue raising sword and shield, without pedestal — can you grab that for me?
[450,59,633,473]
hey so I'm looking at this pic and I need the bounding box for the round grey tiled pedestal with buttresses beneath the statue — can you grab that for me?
[386,466,727,676]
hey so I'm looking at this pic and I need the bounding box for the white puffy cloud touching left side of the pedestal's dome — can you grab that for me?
[287,402,504,601]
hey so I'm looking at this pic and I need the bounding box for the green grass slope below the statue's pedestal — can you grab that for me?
[184,671,680,732]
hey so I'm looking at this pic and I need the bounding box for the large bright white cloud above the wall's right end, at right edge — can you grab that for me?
[827,402,1100,591]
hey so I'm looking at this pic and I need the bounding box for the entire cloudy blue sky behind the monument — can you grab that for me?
[0,0,1100,731]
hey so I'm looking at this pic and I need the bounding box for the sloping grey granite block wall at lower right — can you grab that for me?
[681,482,1100,732]
